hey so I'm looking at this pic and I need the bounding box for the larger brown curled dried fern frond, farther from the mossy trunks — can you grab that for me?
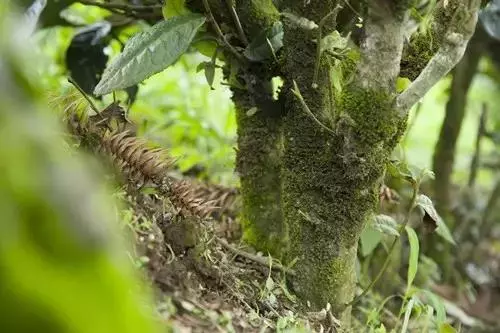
[100,131,174,184]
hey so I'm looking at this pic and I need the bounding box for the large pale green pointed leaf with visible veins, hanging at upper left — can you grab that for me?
[94,14,205,95]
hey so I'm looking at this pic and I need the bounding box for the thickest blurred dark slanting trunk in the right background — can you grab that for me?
[433,28,484,213]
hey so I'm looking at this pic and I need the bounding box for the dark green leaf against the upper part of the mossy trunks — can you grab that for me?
[243,21,283,61]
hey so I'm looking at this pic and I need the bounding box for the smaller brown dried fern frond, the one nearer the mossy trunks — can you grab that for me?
[170,180,219,218]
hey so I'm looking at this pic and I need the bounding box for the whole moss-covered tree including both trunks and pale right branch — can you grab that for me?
[187,0,479,323]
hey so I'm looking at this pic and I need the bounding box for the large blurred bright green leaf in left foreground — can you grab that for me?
[0,6,159,333]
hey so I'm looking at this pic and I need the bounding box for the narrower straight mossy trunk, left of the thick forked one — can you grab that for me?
[233,80,287,257]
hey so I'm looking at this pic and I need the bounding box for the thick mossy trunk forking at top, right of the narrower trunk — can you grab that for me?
[282,1,405,322]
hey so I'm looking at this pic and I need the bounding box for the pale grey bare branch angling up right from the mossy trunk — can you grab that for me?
[396,0,481,114]
